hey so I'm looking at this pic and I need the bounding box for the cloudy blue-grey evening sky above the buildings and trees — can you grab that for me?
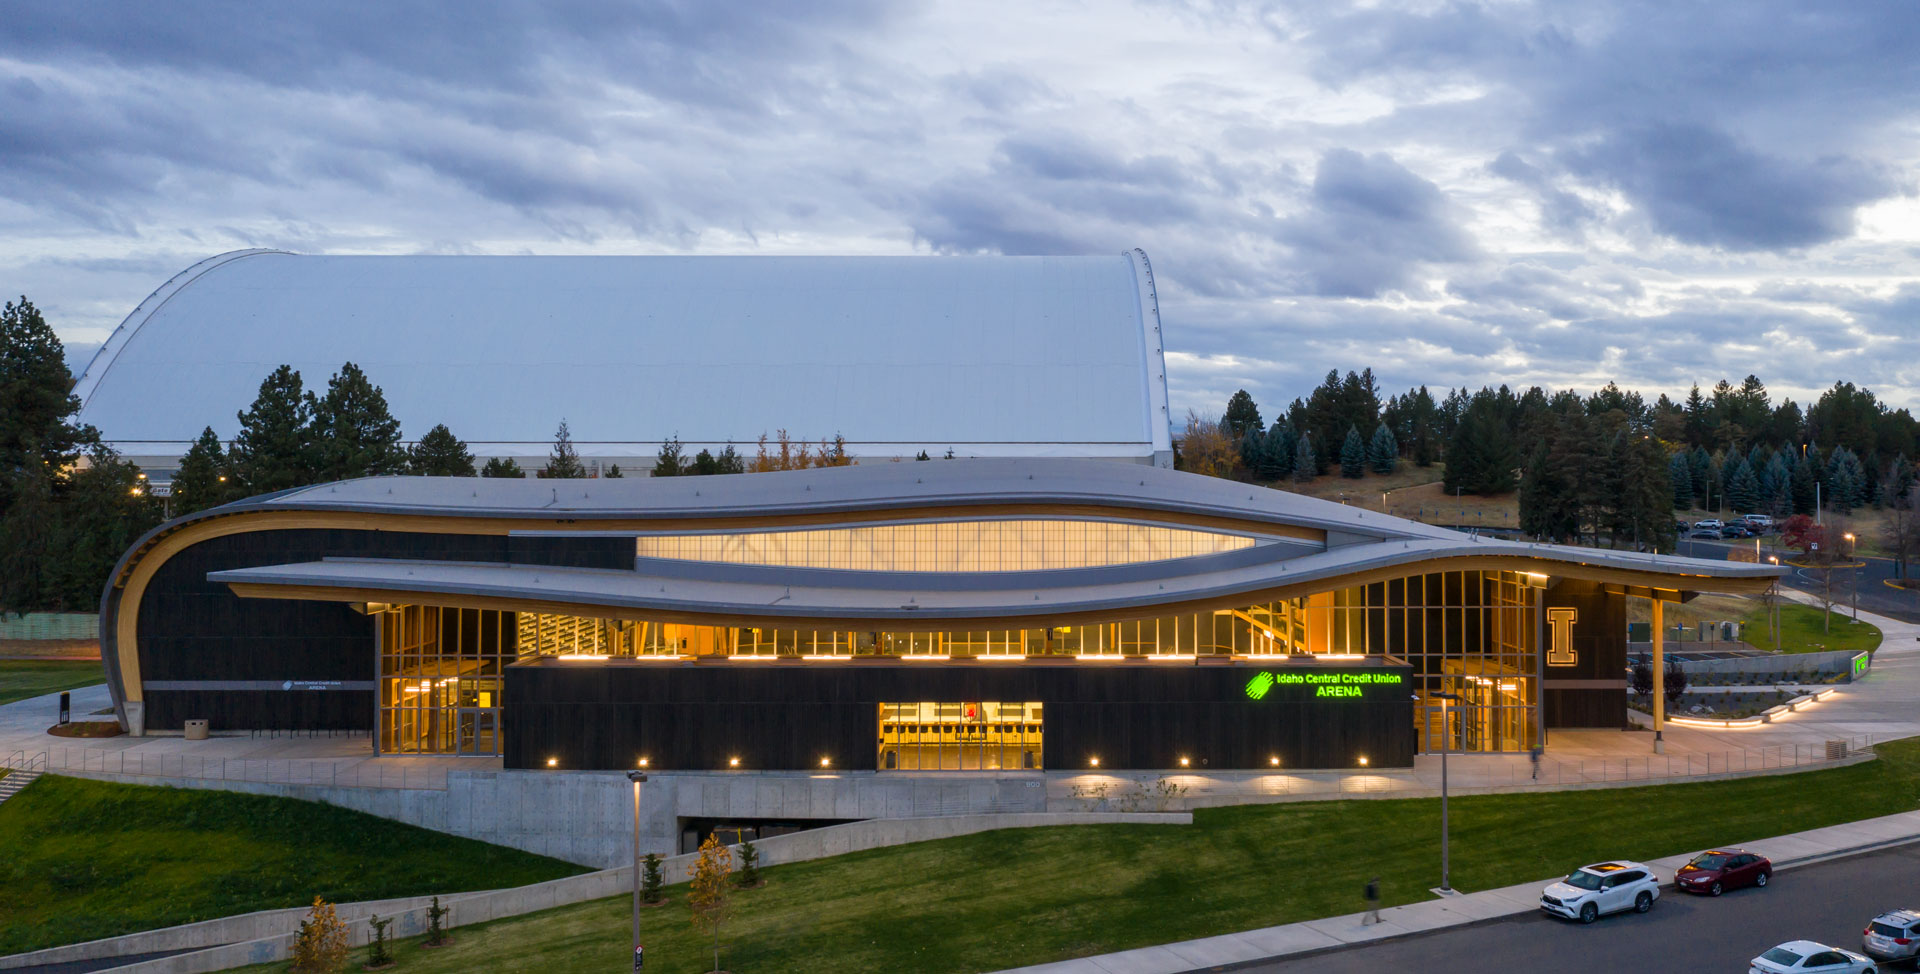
[0,0,1920,415]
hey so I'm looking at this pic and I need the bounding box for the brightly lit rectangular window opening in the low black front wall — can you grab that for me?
[877,701,1043,770]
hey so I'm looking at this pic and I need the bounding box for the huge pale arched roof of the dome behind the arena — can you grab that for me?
[75,250,1171,463]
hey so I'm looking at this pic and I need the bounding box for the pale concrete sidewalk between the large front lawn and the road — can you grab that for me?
[998,813,1920,974]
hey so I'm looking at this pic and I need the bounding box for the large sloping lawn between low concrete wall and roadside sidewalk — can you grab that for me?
[236,742,1920,974]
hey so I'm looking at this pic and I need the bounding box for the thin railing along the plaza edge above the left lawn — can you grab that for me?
[42,747,447,791]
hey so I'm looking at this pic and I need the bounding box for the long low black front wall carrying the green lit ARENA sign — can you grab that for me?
[503,659,1413,770]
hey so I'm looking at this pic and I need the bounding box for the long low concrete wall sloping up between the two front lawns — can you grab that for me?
[0,810,1192,974]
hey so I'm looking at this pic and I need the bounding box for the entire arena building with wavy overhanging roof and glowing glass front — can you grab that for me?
[104,459,1778,772]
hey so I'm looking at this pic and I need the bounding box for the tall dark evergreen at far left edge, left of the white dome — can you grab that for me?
[0,296,86,511]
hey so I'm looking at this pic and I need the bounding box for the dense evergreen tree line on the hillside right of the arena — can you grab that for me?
[1179,369,1920,548]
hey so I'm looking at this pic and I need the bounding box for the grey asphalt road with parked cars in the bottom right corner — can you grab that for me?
[1238,845,1920,974]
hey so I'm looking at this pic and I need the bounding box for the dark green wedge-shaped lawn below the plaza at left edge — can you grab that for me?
[0,774,586,966]
